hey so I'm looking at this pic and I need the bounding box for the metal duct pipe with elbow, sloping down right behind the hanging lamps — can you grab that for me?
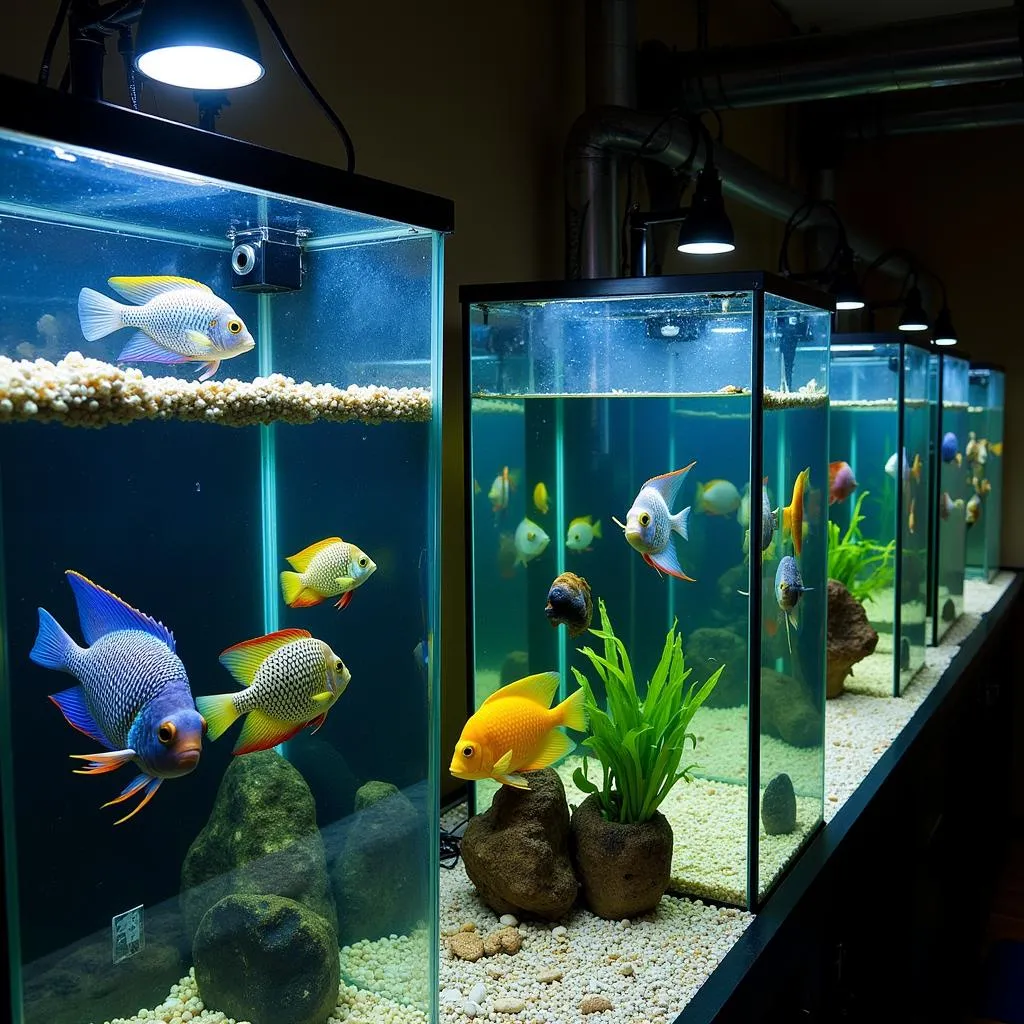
[565,106,907,280]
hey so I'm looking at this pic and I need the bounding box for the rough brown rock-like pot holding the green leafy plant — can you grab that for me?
[570,794,672,921]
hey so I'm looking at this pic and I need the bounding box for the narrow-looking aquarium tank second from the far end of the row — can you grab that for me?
[928,351,966,644]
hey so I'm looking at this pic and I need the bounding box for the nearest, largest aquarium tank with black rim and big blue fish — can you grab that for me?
[0,74,453,1024]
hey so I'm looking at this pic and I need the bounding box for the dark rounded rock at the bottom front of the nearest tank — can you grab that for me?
[193,895,341,1024]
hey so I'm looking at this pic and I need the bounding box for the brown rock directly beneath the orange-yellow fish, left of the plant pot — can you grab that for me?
[462,768,578,921]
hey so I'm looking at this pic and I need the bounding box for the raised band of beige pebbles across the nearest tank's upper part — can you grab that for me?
[0,352,431,428]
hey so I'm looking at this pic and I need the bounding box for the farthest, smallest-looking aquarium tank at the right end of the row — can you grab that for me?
[966,362,1006,581]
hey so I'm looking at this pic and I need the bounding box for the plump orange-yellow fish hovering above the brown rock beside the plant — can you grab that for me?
[449,672,587,790]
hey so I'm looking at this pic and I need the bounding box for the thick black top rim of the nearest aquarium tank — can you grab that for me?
[0,75,455,234]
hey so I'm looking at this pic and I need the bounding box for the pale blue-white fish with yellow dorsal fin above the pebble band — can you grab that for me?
[78,276,256,381]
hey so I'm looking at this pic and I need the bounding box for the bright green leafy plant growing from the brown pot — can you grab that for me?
[572,600,724,823]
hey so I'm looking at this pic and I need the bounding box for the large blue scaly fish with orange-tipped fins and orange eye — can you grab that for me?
[29,569,206,824]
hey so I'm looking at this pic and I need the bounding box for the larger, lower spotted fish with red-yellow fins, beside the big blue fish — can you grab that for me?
[196,630,352,755]
